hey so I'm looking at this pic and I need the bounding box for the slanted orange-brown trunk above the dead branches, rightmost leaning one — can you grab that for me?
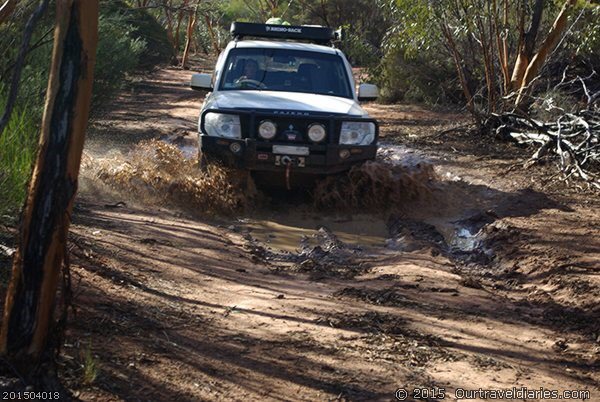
[515,0,577,107]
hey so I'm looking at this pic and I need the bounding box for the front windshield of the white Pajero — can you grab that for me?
[219,48,352,98]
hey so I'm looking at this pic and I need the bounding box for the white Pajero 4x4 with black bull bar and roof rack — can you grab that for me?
[191,22,379,187]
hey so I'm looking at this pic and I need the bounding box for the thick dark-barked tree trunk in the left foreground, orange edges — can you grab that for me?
[0,0,98,376]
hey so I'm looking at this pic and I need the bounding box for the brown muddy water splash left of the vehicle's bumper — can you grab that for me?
[83,140,255,215]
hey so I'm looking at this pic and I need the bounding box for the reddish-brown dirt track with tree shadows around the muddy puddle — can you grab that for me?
[61,61,600,401]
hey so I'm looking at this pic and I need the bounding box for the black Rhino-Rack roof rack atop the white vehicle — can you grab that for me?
[231,21,341,45]
